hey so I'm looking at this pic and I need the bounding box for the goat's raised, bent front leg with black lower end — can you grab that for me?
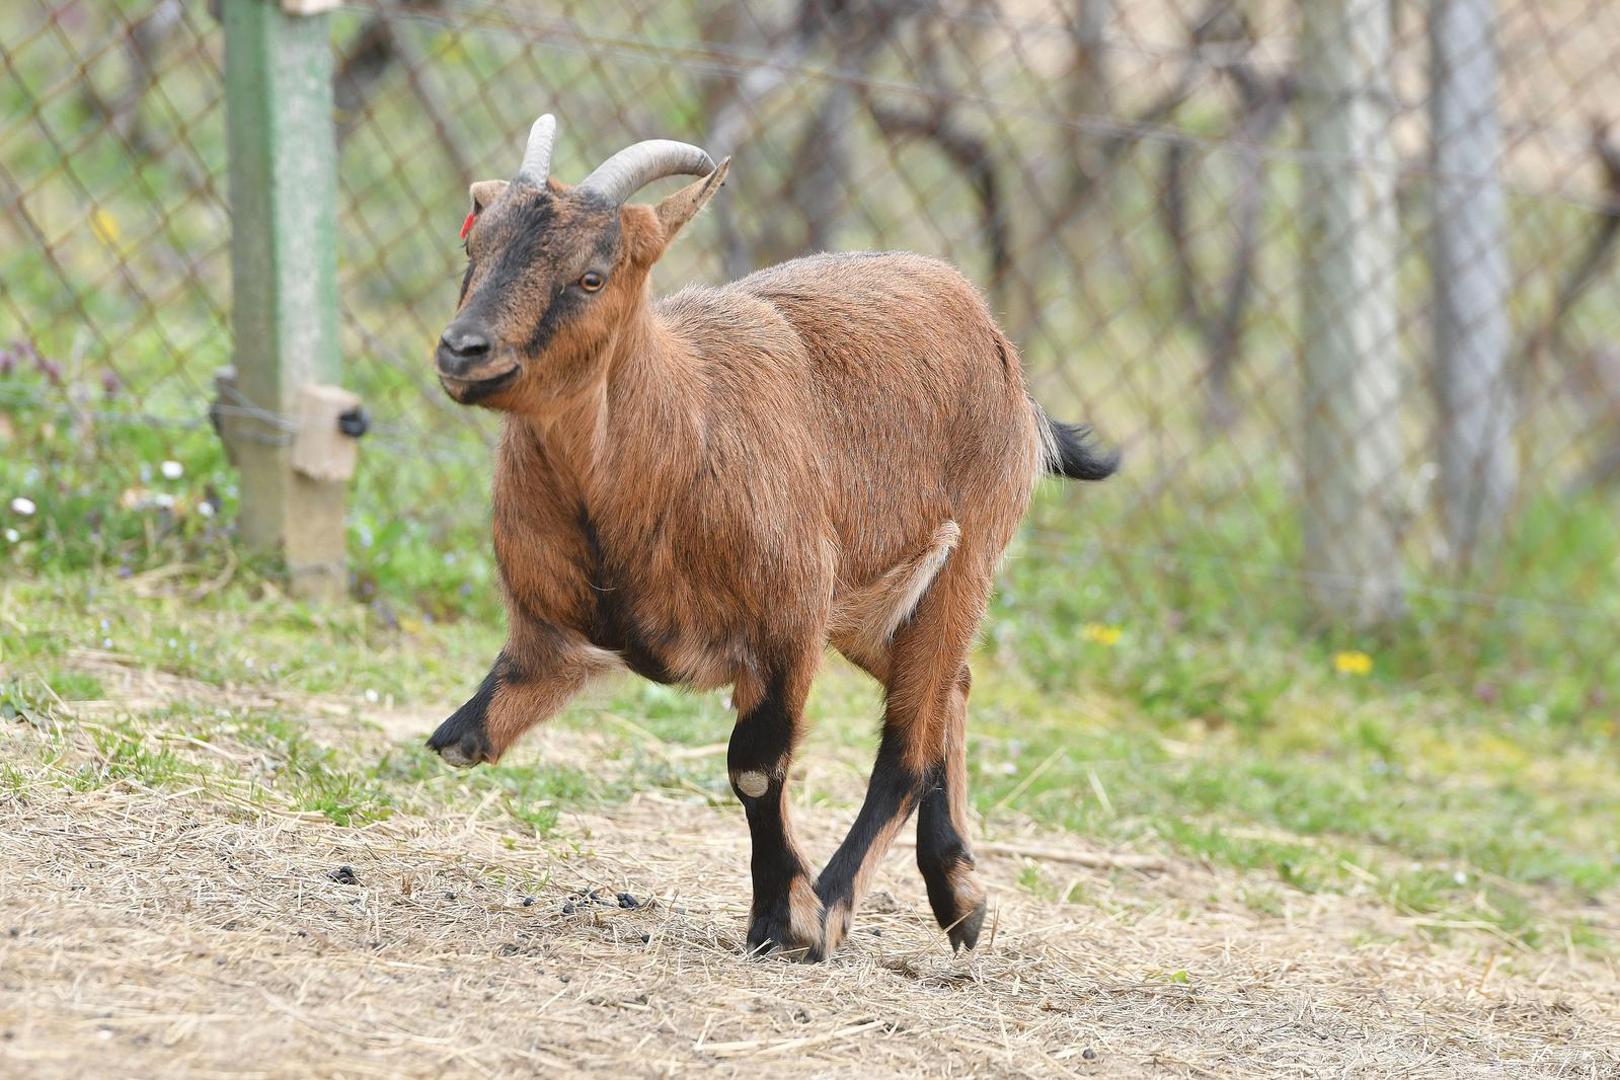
[428,620,616,767]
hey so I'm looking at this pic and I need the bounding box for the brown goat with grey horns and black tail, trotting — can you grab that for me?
[428,117,1115,959]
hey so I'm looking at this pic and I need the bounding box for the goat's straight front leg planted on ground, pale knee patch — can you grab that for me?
[726,664,821,960]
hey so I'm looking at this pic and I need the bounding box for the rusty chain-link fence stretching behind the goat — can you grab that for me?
[0,0,1620,703]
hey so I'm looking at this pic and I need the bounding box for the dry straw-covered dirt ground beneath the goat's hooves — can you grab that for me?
[0,670,1620,1077]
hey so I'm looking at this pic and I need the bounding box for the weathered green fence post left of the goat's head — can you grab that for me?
[219,0,347,599]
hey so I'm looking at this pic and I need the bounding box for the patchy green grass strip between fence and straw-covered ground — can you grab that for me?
[0,568,1620,952]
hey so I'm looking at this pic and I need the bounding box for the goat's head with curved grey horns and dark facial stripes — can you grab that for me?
[436,117,727,413]
